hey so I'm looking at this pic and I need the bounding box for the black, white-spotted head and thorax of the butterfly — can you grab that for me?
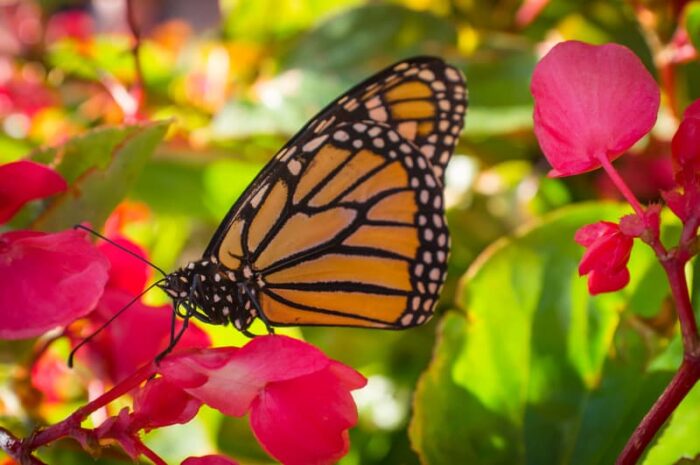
[160,257,257,330]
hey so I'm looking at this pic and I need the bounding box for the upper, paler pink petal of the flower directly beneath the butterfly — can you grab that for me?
[161,336,331,416]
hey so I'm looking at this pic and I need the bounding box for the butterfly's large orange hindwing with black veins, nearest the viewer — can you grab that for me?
[217,121,449,328]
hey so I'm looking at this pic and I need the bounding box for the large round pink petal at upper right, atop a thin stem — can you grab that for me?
[530,41,659,177]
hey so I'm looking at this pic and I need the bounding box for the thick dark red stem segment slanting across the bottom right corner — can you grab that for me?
[615,357,700,465]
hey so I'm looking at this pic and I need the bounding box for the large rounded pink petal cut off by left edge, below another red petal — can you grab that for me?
[0,230,109,339]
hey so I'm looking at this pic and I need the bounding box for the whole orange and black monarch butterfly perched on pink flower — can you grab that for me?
[159,57,467,346]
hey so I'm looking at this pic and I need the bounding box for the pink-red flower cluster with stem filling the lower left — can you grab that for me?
[0,161,366,465]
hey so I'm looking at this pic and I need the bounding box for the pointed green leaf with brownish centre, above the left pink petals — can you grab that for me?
[32,121,170,231]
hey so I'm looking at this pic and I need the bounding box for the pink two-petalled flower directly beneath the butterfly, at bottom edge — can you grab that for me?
[161,336,366,465]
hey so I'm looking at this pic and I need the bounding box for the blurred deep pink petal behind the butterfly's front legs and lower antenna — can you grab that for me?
[78,288,211,383]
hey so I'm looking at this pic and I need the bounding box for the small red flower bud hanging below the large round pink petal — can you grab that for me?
[574,221,633,295]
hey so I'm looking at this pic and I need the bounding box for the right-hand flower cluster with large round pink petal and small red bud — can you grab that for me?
[531,41,700,294]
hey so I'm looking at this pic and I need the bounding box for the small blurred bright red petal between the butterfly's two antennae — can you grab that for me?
[98,236,150,295]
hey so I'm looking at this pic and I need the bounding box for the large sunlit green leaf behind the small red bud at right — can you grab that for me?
[410,204,688,465]
